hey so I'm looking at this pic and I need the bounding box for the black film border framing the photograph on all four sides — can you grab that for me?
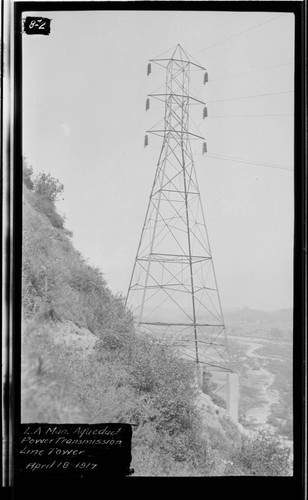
[2,0,307,500]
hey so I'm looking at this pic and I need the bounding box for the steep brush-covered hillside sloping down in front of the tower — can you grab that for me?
[21,164,289,476]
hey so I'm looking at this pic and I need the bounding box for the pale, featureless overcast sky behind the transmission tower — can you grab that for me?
[23,11,294,310]
